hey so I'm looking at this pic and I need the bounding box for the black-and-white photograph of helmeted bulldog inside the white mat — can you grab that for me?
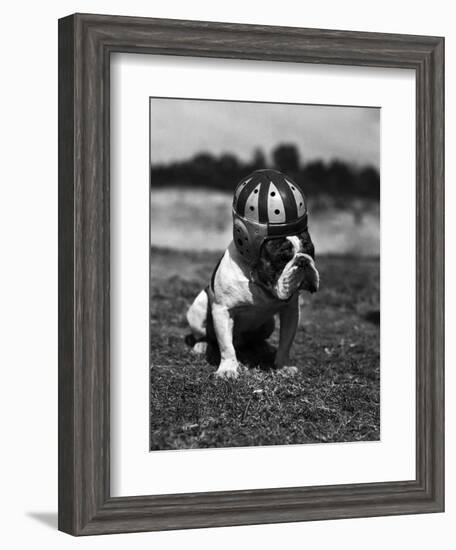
[150,97,381,451]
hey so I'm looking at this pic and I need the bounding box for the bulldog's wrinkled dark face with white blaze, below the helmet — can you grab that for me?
[254,231,320,300]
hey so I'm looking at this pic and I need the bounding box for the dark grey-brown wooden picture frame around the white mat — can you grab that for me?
[58,14,444,535]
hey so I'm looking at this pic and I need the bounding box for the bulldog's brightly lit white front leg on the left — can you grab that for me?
[212,304,239,378]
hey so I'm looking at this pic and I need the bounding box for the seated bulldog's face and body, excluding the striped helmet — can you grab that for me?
[187,229,319,378]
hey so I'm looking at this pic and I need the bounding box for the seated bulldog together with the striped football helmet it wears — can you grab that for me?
[187,169,320,378]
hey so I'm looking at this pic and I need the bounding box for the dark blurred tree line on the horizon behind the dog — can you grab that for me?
[151,143,380,202]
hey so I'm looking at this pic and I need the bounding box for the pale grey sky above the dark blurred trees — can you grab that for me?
[150,98,380,168]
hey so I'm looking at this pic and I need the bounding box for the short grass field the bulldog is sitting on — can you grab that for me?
[150,248,380,450]
